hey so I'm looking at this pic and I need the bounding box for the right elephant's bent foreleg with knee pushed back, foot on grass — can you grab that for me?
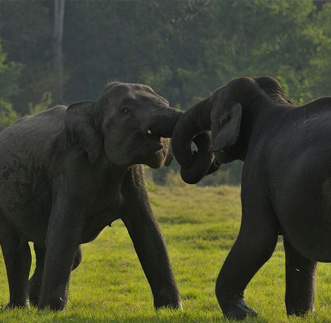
[216,194,278,319]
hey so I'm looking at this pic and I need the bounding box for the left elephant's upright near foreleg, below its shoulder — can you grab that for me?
[38,177,84,310]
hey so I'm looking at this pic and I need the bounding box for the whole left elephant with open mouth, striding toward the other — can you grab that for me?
[0,82,181,310]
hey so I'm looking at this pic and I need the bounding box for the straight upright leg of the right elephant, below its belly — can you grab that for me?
[284,237,317,315]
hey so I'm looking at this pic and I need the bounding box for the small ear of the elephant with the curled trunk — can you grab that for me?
[213,103,242,151]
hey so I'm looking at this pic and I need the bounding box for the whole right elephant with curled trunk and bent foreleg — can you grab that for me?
[171,76,331,319]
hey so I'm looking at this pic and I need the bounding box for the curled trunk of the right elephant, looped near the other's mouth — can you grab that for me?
[171,98,218,184]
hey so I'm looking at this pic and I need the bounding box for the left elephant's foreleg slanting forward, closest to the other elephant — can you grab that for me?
[122,168,181,308]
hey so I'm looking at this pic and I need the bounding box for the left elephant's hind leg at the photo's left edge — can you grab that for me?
[0,215,31,307]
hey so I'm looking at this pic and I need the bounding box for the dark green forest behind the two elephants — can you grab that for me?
[0,0,331,185]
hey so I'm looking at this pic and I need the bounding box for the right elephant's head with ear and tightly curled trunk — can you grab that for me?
[172,76,288,183]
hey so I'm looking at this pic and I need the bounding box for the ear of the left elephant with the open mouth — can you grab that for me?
[64,101,102,163]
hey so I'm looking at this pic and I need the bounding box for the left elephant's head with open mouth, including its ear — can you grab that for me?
[65,82,182,168]
